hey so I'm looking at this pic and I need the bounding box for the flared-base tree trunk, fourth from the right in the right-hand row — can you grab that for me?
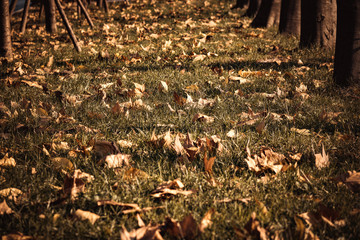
[251,0,281,27]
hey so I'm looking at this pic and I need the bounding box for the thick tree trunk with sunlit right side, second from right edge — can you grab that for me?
[300,0,337,49]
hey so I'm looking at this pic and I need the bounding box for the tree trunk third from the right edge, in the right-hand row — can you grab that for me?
[279,0,301,36]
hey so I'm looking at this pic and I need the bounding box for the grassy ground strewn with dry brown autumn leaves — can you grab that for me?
[0,0,360,239]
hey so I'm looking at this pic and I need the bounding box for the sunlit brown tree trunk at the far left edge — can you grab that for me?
[0,0,13,61]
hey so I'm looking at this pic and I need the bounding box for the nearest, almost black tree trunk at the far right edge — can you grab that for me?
[334,0,360,86]
